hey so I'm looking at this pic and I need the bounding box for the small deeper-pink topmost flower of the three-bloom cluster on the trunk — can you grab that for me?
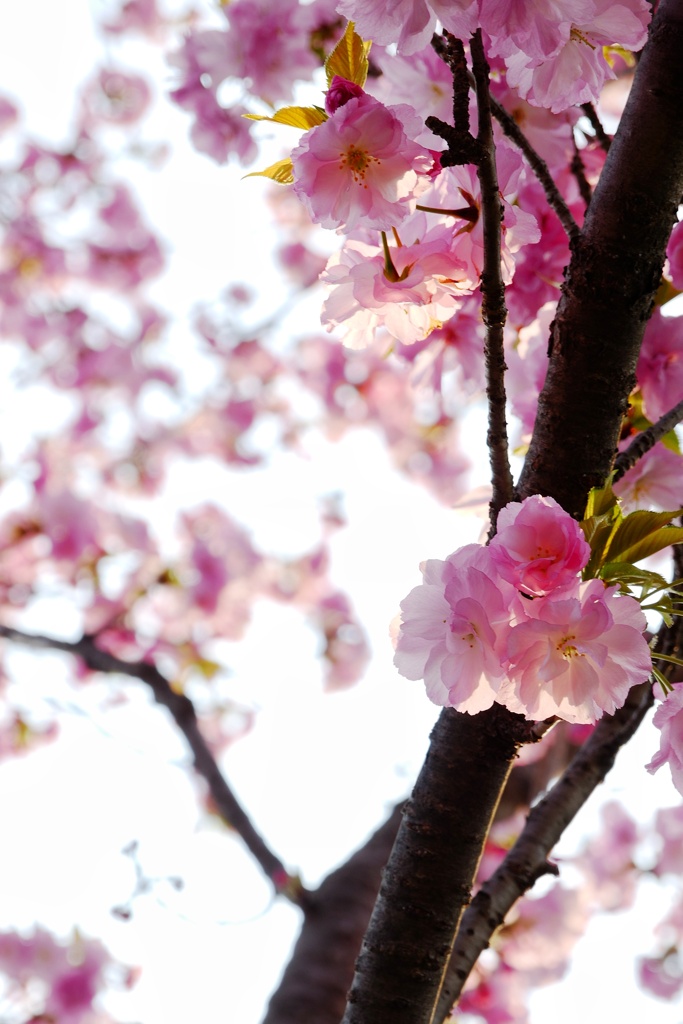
[489,495,591,597]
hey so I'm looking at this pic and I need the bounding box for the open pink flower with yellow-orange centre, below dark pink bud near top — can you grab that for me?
[292,93,431,230]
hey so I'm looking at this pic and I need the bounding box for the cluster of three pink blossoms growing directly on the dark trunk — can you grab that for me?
[394,495,652,724]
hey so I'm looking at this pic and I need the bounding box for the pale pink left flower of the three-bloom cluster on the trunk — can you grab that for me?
[394,544,516,714]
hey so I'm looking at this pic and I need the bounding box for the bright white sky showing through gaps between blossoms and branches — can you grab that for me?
[0,0,681,1024]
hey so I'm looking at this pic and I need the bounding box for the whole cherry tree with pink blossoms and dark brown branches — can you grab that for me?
[0,0,683,1024]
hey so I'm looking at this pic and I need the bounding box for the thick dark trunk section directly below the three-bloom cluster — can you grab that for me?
[343,705,538,1024]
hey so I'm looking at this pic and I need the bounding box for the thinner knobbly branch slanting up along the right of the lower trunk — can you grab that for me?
[434,683,652,1024]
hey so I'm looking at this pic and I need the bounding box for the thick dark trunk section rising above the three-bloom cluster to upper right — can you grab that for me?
[519,0,683,517]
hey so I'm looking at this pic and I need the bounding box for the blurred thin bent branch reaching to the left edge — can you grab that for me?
[0,626,307,904]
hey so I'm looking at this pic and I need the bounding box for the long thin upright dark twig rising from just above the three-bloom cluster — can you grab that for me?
[471,31,514,537]
